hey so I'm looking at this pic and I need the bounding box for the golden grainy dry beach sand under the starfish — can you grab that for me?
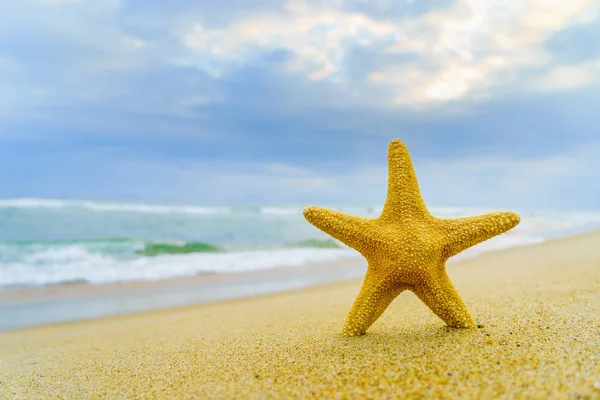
[0,233,600,399]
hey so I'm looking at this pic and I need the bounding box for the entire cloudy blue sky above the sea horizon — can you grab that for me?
[0,0,600,210]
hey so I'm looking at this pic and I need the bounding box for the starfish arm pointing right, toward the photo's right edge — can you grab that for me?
[440,212,520,258]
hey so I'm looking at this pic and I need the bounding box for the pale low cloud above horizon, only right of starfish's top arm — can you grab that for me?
[414,142,600,209]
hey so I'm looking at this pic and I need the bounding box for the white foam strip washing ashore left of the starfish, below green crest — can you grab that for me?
[0,245,360,286]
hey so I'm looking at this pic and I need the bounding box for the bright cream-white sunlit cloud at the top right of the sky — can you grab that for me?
[183,0,597,107]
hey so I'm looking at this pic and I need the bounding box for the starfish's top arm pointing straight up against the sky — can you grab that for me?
[381,139,428,220]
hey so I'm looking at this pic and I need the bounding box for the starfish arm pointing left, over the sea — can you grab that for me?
[304,206,376,255]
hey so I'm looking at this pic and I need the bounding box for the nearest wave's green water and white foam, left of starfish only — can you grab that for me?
[0,237,356,286]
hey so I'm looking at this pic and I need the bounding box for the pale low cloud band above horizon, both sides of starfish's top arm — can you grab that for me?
[312,142,600,210]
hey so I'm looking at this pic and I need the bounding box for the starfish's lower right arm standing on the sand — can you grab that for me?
[411,271,476,328]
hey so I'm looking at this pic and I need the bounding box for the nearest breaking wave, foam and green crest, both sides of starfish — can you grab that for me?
[0,231,543,286]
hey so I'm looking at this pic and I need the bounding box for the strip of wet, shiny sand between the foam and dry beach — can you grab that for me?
[0,231,600,332]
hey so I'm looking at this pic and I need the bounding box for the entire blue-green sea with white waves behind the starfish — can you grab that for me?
[0,198,600,287]
